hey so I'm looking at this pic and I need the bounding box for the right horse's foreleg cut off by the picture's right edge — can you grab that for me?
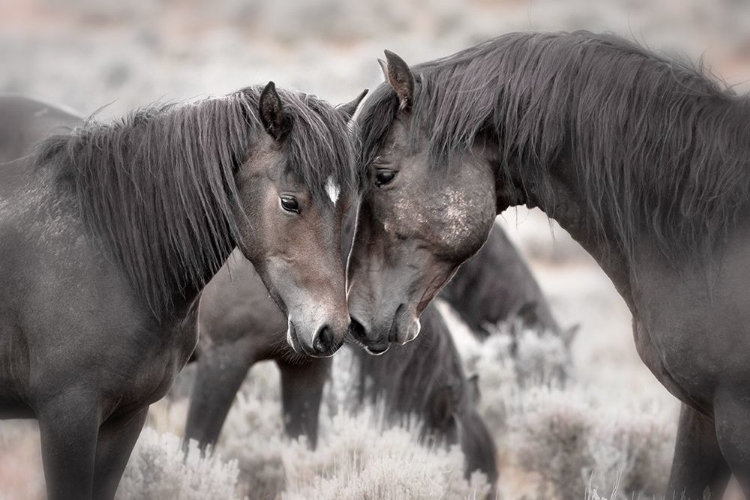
[714,392,750,498]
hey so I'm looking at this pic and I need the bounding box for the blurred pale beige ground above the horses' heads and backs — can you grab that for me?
[0,0,750,115]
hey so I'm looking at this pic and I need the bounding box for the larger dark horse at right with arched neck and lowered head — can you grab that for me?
[348,32,750,499]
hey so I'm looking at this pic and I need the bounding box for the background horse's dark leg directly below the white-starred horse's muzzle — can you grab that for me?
[276,358,332,448]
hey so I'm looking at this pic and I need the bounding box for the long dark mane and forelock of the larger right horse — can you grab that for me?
[357,32,750,260]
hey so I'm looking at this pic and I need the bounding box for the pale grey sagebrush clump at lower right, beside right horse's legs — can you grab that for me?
[504,370,676,500]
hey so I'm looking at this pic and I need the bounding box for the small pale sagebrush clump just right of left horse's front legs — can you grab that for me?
[117,428,241,500]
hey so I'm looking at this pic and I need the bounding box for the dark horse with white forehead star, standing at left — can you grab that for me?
[0,88,362,499]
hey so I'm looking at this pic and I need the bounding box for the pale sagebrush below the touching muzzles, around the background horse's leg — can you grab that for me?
[209,360,489,500]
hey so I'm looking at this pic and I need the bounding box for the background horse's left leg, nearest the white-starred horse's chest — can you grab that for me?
[183,344,253,449]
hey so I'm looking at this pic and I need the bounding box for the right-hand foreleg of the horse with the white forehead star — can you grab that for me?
[94,406,148,500]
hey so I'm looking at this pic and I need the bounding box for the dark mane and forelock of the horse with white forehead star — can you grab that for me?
[35,86,354,318]
